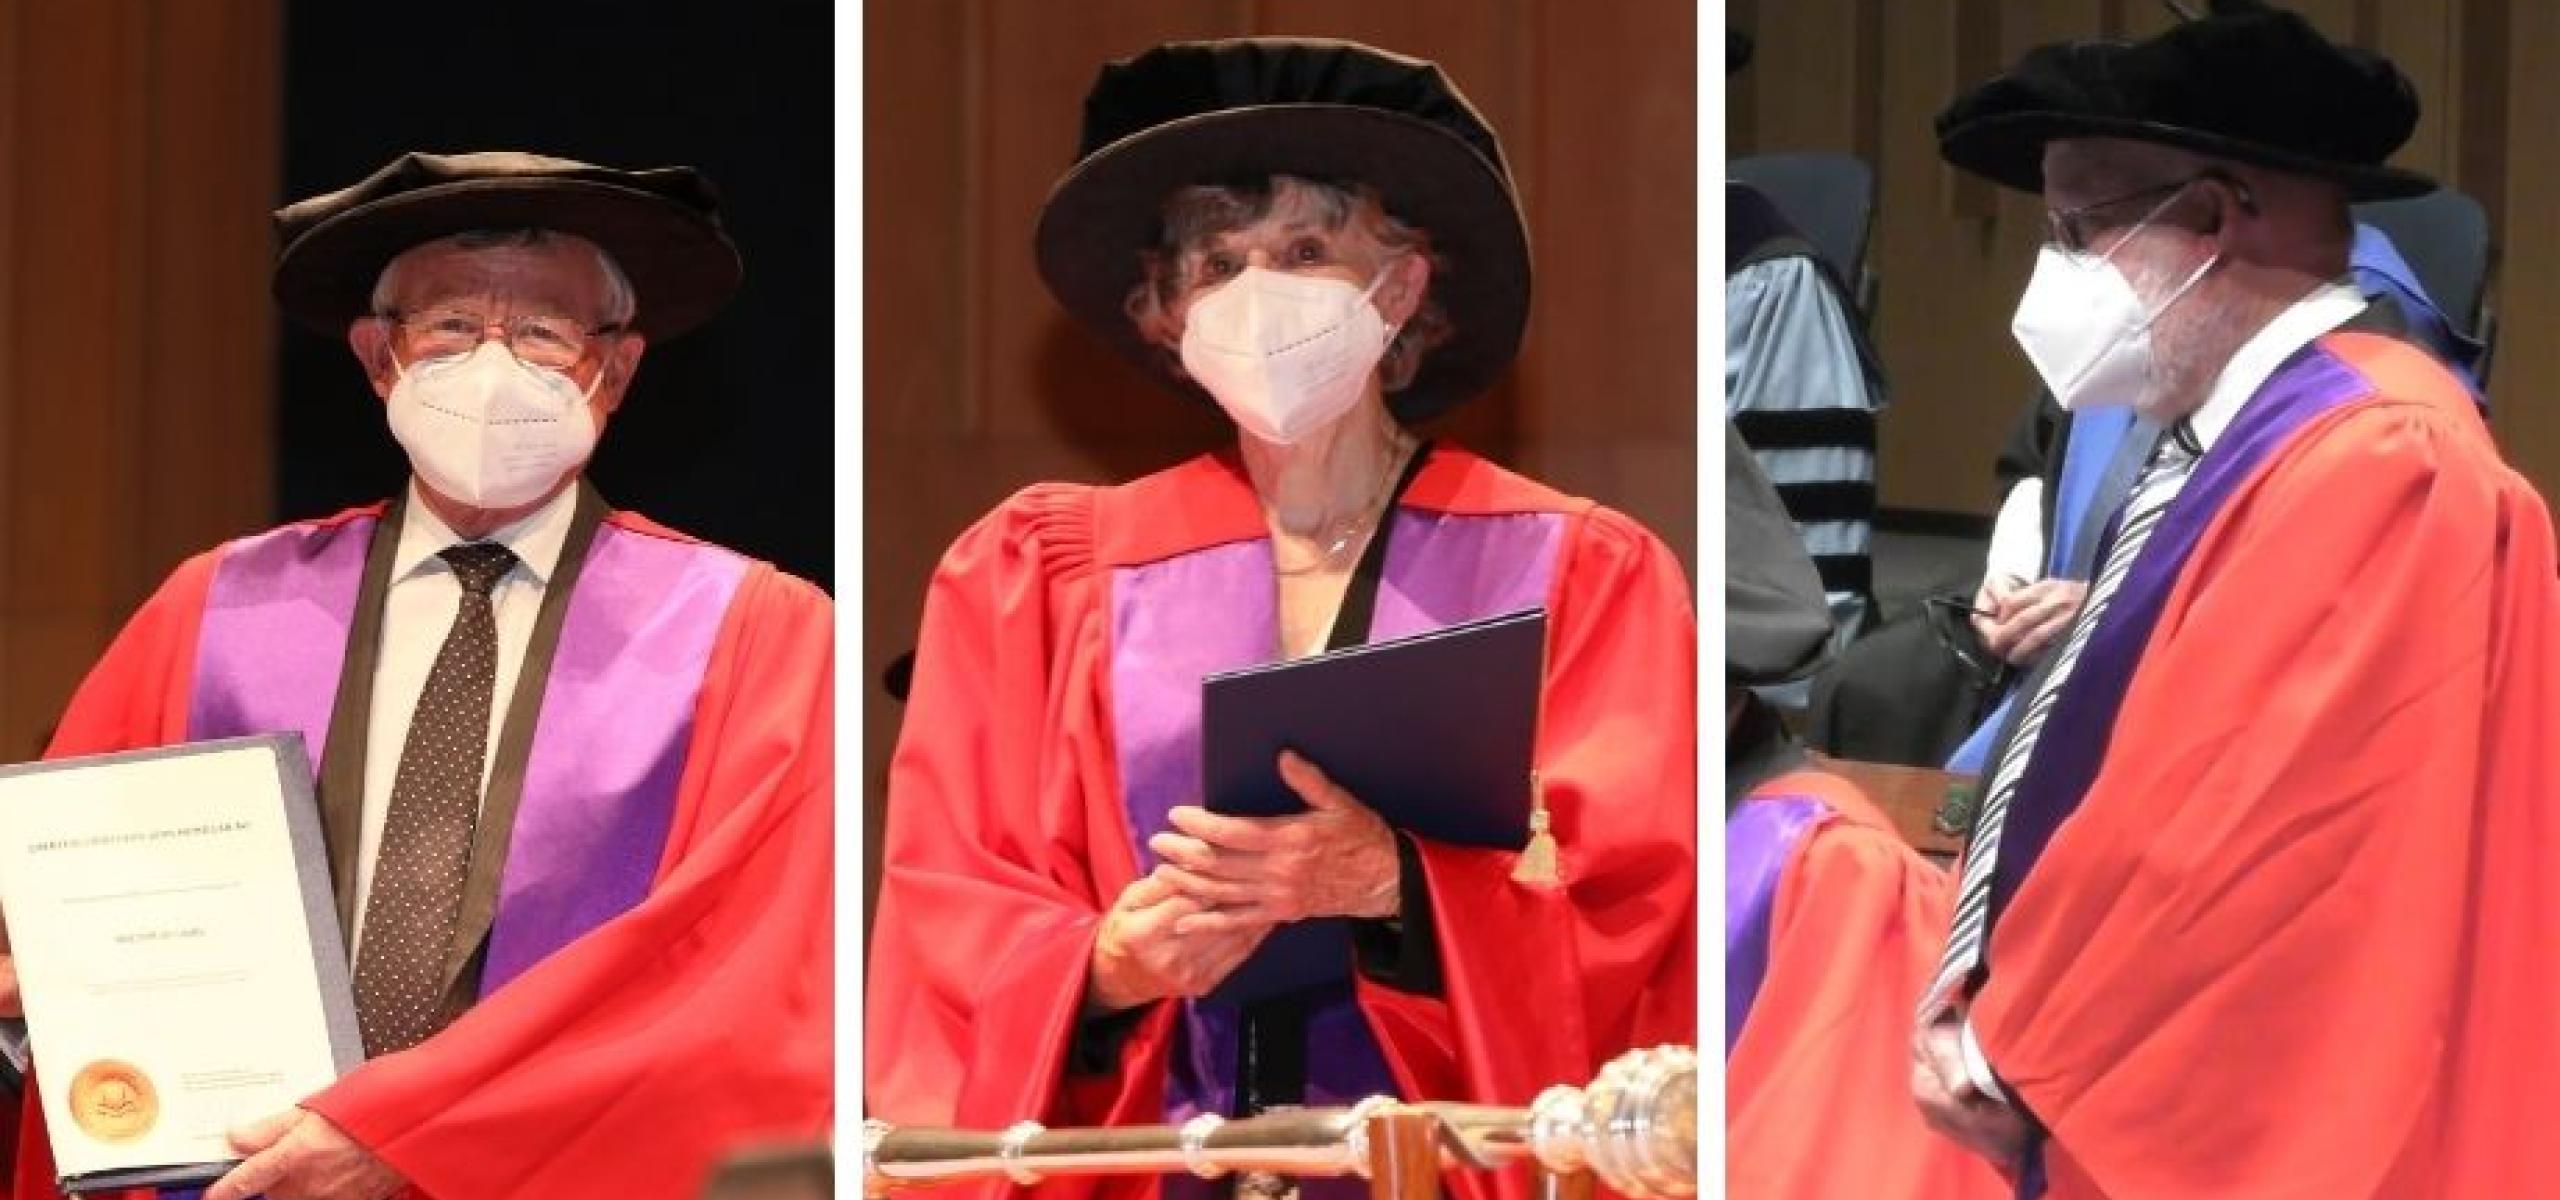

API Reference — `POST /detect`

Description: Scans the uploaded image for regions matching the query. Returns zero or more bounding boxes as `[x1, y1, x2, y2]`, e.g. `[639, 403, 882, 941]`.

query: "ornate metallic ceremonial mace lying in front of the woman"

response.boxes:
[863, 1046, 1697, 1197]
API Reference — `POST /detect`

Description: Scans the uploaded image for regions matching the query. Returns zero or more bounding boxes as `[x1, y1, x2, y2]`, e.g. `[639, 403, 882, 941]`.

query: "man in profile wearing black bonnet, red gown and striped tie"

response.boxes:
[1912, 0, 2560, 1197]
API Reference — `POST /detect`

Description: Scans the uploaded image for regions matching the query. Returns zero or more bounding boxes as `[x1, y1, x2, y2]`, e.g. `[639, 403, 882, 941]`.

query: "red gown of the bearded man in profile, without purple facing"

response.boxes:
[1971, 335, 2560, 1200]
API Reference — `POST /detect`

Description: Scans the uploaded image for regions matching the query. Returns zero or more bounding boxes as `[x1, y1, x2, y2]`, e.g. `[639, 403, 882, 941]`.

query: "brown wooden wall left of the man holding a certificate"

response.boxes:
[0, 0, 276, 760]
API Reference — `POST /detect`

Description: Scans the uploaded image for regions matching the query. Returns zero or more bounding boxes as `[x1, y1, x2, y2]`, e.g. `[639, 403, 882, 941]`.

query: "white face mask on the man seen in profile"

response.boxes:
[2010, 246, 2222, 412]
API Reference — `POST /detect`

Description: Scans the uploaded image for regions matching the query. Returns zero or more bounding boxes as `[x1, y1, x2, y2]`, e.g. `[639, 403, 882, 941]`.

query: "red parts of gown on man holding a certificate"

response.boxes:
[10, 504, 835, 1200]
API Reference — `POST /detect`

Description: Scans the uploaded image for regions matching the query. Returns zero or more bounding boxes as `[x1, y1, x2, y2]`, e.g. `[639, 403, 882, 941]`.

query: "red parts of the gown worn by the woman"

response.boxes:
[863, 450, 1697, 1197]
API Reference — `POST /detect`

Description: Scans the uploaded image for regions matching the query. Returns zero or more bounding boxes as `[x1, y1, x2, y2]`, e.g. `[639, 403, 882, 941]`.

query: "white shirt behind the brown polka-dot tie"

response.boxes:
[351, 481, 579, 944]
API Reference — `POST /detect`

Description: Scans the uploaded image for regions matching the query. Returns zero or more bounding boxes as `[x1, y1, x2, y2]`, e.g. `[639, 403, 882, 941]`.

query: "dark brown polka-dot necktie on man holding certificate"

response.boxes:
[356, 542, 515, 1054]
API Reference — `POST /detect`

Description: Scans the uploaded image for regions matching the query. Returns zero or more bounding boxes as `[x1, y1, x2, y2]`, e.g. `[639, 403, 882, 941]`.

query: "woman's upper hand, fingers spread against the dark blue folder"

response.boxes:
[1147, 752, 1398, 934]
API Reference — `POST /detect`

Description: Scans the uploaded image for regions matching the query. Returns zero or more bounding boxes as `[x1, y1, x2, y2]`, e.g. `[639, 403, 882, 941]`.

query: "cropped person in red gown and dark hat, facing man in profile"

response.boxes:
[1725, 425, 2010, 1200]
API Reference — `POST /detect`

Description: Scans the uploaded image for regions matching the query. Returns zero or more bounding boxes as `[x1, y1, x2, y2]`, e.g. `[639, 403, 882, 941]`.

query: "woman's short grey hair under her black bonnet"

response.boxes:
[1121, 174, 1457, 391]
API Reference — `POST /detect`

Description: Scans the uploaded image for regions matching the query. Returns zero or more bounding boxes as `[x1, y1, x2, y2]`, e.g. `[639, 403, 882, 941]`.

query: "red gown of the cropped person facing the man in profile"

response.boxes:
[1725, 770, 2010, 1200]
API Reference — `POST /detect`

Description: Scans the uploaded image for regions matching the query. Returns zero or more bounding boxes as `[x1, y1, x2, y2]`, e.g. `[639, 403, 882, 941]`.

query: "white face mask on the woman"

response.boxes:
[1183, 266, 1395, 445]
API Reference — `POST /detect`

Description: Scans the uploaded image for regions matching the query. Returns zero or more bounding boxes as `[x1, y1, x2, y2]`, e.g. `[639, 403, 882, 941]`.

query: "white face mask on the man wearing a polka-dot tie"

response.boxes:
[384, 338, 604, 509]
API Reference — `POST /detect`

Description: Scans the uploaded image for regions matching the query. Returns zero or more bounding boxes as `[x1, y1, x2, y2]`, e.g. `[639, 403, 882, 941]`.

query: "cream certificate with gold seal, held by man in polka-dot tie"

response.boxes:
[0, 734, 364, 1192]
